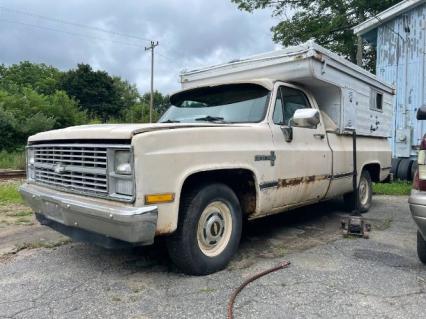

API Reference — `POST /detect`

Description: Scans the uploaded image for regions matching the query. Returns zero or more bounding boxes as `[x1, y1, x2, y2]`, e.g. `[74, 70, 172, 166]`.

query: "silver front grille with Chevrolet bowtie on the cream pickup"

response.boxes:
[31, 144, 108, 196]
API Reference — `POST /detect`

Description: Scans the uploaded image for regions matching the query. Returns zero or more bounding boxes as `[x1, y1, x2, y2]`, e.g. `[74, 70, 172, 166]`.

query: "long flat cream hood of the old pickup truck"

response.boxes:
[28, 123, 240, 142]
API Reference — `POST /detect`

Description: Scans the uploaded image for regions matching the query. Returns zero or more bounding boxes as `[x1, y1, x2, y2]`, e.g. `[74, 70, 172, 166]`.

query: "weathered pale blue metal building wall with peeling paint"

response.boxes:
[376, 4, 426, 157]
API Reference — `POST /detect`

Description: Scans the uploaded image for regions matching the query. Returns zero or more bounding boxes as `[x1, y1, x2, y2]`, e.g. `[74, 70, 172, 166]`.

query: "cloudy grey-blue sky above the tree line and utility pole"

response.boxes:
[0, 0, 278, 93]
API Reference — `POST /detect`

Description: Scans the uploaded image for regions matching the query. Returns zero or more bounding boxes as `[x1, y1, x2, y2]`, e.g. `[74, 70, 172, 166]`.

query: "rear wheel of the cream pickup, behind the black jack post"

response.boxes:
[343, 170, 373, 213]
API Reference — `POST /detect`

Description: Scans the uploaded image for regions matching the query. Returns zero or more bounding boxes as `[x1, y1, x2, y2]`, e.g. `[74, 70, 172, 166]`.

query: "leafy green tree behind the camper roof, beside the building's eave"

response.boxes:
[231, 0, 400, 68]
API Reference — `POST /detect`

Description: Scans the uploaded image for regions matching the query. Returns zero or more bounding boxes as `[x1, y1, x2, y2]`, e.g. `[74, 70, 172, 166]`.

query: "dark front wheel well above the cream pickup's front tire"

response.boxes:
[181, 169, 256, 215]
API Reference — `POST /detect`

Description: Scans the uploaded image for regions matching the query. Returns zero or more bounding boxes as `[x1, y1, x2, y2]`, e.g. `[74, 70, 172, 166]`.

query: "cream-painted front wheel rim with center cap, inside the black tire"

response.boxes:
[197, 201, 232, 257]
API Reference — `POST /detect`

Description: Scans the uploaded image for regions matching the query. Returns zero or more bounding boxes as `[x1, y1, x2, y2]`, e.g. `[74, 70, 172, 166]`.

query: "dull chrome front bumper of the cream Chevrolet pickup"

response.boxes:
[20, 183, 158, 245]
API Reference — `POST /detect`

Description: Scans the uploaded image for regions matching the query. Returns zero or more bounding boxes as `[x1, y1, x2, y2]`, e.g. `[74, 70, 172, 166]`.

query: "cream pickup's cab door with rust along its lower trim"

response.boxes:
[269, 83, 332, 208]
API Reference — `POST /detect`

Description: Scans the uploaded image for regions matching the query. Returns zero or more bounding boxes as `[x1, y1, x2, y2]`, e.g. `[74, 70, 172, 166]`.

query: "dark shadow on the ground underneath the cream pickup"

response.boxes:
[68, 200, 344, 273]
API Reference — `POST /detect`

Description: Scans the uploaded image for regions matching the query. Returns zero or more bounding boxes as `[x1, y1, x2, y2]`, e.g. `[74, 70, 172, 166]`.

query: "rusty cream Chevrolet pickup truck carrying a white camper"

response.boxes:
[21, 43, 393, 275]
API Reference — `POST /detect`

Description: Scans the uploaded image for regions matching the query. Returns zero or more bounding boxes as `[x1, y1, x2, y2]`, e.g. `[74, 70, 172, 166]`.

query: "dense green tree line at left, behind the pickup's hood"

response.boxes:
[0, 61, 169, 151]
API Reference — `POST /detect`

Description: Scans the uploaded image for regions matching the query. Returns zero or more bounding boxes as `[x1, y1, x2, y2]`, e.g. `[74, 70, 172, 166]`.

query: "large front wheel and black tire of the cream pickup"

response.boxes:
[167, 183, 242, 275]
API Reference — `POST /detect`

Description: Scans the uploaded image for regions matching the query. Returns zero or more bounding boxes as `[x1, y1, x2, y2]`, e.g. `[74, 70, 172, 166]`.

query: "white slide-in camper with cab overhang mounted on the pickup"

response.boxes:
[180, 41, 395, 137]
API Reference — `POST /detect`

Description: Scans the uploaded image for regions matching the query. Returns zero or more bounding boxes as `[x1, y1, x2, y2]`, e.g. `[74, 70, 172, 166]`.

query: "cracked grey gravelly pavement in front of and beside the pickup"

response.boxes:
[0, 196, 426, 318]
